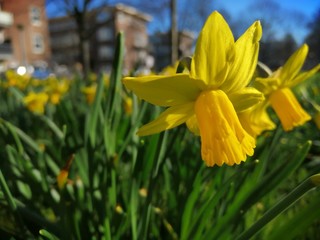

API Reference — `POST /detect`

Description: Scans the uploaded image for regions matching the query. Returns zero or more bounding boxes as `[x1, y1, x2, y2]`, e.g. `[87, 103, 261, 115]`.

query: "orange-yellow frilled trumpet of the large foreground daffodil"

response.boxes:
[195, 90, 255, 166]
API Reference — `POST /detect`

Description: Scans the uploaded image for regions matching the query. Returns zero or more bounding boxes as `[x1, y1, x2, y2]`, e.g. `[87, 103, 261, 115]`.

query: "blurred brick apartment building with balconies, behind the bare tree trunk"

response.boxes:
[49, 4, 151, 72]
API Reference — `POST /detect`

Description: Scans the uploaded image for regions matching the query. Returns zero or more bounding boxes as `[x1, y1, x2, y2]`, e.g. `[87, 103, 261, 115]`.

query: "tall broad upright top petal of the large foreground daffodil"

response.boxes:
[190, 11, 234, 87]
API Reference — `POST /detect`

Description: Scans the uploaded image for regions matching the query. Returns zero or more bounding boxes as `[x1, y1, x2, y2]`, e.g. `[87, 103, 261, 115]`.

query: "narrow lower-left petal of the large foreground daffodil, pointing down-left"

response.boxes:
[137, 102, 194, 136]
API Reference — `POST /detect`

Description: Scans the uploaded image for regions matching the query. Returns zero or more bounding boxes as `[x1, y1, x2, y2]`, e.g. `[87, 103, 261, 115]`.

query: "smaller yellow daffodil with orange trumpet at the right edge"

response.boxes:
[254, 44, 320, 131]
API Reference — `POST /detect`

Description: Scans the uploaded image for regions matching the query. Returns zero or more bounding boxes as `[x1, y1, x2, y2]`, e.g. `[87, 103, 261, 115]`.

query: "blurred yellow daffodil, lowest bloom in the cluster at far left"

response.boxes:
[23, 92, 49, 114]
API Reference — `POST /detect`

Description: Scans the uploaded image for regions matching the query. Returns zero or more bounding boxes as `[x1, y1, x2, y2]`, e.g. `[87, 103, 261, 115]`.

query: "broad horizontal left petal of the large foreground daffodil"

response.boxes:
[122, 74, 200, 107]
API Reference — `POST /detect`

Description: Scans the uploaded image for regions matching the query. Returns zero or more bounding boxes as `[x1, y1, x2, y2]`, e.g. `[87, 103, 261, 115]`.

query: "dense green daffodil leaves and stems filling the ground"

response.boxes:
[0, 34, 320, 240]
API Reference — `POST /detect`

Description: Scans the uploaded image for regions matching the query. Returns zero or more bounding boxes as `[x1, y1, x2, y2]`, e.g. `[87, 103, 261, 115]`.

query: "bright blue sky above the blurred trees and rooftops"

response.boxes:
[47, 0, 320, 44]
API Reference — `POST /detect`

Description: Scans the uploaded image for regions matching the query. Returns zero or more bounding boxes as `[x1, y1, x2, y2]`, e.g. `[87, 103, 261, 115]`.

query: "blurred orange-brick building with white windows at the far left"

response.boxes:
[0, 0, 51, 69]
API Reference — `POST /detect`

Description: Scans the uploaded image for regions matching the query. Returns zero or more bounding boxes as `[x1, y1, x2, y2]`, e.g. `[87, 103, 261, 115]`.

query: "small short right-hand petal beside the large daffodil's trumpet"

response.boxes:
[228, 87, 264, 112]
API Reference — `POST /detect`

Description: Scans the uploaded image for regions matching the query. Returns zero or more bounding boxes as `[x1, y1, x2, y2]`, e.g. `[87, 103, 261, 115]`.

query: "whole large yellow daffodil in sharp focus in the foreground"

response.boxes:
[123, 12, 263, 166]
